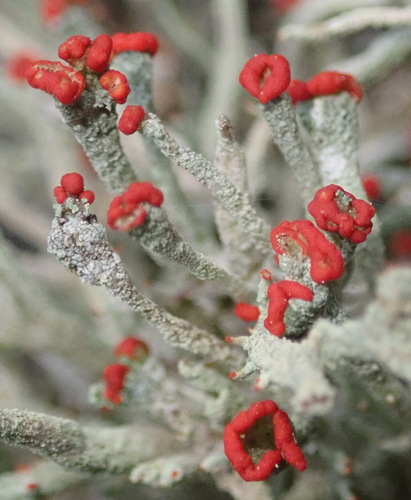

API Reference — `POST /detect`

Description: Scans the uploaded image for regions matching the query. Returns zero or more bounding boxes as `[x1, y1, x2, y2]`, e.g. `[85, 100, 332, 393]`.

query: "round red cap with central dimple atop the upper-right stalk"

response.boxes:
[239, 54, 290, 104]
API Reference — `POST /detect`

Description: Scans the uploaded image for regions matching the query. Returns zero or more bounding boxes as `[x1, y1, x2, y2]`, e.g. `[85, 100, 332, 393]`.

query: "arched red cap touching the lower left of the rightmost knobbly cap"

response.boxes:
[270, 220, 344, 283]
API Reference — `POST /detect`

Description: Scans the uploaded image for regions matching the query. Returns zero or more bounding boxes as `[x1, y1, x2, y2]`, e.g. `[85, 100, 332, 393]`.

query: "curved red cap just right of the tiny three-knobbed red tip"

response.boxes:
[107, 182, 164, 231]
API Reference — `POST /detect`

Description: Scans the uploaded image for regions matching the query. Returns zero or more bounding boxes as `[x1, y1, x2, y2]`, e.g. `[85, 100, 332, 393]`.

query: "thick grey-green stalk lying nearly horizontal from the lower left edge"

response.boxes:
[0, 409, 178, 474]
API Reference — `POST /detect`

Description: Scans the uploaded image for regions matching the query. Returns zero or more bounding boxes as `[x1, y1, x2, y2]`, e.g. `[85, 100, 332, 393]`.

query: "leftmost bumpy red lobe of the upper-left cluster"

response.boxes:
[26, 61, 86, 105]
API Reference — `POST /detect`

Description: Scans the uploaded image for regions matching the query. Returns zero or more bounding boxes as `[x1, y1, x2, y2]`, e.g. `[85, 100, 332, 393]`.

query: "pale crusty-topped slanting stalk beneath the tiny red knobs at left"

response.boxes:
[48, 201, 240, 361]
